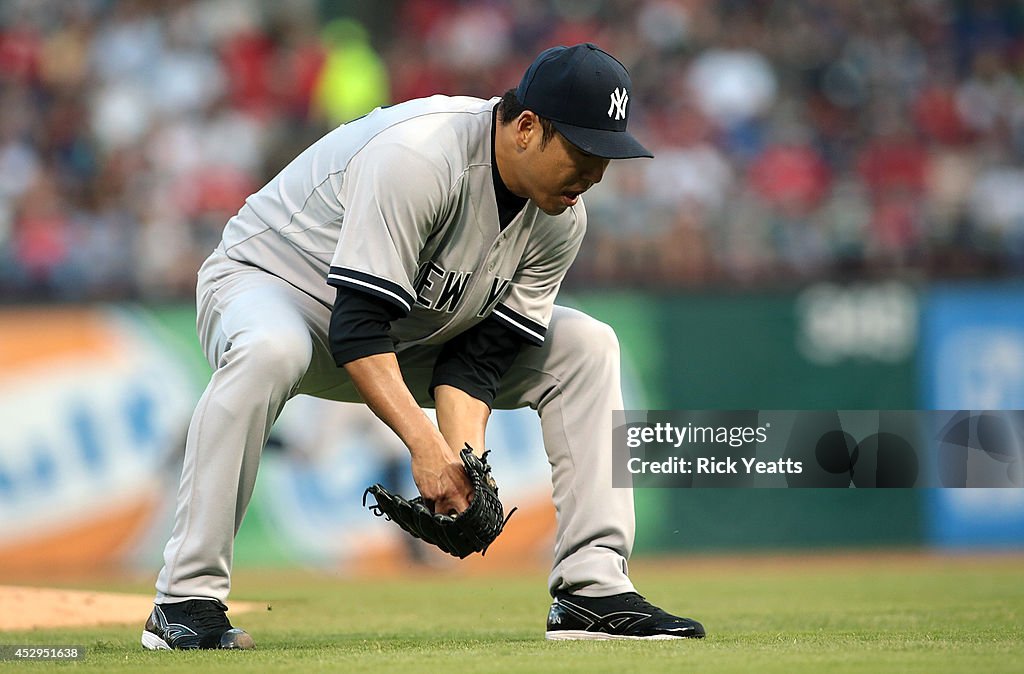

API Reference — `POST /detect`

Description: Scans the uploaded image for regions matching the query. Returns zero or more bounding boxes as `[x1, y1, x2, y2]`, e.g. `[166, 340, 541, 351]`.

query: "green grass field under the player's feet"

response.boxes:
[0, 555, 1024, 674]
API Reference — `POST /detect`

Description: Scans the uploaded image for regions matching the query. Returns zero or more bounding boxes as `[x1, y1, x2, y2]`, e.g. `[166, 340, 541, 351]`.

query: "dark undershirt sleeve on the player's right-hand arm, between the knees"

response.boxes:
[430, 315, 525, 407]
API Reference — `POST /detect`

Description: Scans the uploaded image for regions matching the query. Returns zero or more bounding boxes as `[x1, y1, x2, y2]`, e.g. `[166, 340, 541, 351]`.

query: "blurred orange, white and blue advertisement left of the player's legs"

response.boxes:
[0, 307, 196, 573]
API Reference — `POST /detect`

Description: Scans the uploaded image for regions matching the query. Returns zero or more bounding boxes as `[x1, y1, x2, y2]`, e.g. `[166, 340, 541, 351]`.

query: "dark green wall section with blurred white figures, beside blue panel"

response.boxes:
[573, 282, 923, 553]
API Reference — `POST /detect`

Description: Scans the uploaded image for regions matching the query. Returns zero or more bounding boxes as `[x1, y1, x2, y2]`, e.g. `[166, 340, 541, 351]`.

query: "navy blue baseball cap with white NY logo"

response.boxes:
[515, 42, 654, 159]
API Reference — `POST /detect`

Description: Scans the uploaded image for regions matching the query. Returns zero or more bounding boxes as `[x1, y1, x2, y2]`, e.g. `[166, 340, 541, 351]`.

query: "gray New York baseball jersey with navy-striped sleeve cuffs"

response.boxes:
[222, 95, 587, 351]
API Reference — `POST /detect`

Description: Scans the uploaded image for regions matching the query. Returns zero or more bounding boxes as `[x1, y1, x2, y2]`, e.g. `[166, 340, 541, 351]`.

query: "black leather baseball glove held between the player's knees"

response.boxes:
[362, 445, 516, 559]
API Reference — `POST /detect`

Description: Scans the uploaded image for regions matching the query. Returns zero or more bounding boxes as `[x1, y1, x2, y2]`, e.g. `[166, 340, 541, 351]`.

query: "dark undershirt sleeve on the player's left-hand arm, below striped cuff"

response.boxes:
[328, 287, 401, 368]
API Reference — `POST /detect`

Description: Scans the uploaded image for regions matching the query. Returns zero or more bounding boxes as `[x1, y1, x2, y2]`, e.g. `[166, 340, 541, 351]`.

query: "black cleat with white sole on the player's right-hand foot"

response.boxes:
[544, 592, 705, 640]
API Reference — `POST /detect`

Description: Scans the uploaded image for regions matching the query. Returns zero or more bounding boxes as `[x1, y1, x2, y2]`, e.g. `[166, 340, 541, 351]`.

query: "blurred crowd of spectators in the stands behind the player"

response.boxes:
[0, 0, 1024, 301]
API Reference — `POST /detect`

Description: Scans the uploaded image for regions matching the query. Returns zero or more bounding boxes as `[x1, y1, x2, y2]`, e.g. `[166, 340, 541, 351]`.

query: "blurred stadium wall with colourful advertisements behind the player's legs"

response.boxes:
[0, 282, 1024, 574]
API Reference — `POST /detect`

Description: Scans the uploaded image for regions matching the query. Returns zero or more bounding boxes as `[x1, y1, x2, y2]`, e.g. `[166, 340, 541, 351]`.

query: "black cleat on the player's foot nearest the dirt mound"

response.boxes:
[142, 599, 256, 650]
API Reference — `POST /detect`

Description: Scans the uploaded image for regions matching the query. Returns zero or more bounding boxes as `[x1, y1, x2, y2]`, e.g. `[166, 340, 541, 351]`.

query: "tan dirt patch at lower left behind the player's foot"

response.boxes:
[0, 585, 256, 630]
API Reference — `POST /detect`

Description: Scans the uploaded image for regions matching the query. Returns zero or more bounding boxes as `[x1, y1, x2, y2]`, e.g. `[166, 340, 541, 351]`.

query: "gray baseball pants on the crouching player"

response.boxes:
[156, 252, 635, 603]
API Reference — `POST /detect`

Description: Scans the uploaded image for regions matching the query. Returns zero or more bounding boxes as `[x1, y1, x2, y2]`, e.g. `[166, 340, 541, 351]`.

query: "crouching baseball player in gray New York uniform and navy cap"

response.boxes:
[142, 43, 705, 649]
